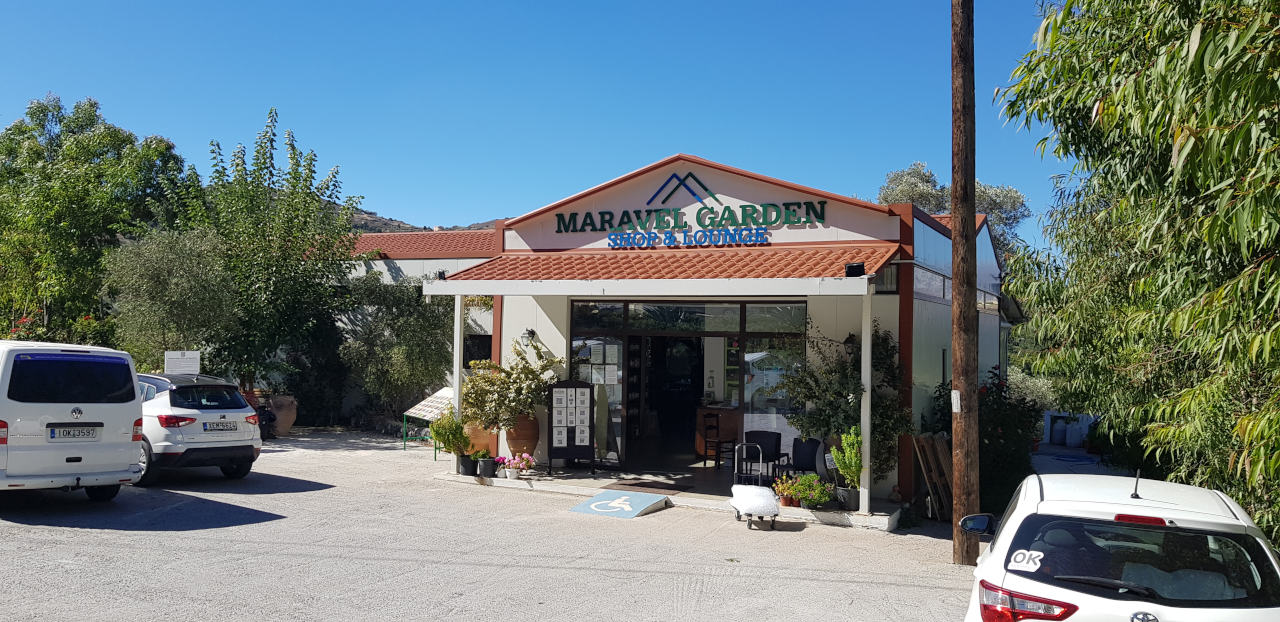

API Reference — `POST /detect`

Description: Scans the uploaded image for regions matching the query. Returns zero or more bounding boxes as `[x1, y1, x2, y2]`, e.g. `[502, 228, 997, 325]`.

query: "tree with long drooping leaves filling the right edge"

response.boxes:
[1002, 0, 1280, 538]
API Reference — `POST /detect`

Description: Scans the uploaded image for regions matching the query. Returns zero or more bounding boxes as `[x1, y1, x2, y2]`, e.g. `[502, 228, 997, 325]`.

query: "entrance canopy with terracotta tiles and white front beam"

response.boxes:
[422, 243, 897, 297]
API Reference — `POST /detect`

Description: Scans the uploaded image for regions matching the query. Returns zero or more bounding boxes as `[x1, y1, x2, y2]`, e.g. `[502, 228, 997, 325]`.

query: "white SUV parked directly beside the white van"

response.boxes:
[138, 374, 262, 486]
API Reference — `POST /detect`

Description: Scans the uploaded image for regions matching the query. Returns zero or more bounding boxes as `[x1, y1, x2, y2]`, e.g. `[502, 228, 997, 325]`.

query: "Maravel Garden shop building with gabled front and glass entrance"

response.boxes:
[424, 155, 1009, 507]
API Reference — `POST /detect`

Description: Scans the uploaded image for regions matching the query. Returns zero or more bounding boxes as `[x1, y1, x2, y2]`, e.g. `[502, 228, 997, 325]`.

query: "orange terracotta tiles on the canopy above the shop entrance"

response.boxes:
[449, 244, 897, 280]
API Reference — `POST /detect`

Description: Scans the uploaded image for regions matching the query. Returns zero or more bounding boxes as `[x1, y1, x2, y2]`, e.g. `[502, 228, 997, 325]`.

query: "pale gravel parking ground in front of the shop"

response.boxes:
[0, 430, 972, 621]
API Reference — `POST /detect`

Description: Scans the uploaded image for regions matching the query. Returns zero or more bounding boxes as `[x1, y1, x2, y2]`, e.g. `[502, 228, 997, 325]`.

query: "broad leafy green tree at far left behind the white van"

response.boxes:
[0, 95, 198, 339]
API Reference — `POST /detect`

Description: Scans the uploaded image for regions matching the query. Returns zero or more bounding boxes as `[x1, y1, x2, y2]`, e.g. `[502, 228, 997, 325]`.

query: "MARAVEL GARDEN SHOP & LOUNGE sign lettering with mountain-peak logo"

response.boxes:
[556, 173, 827, 248]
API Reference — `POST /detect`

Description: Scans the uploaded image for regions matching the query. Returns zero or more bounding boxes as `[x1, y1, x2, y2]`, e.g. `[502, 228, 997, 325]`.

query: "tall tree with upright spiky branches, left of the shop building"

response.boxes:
[199, 109, 361, 387]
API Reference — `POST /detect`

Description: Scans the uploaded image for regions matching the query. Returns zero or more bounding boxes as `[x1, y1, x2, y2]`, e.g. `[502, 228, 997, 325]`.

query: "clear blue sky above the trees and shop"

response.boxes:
[0, 0, 1068, 241]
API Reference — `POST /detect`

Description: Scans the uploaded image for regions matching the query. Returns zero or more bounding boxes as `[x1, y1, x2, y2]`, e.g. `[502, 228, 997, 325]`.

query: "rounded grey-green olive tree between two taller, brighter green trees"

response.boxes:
[105, 228, 237, 369]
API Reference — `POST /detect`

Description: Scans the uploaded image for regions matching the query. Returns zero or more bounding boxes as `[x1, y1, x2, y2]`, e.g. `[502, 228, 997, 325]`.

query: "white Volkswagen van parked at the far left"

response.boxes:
[0, 340, 142, 502]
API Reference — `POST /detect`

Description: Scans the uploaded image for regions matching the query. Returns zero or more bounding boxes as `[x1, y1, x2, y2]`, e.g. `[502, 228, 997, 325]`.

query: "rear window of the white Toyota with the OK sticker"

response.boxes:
[1005, 514, 1280, 607]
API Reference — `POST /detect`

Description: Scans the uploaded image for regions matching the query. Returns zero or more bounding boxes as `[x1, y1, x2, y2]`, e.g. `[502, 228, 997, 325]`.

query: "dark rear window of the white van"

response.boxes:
[8, 352, 138, 404]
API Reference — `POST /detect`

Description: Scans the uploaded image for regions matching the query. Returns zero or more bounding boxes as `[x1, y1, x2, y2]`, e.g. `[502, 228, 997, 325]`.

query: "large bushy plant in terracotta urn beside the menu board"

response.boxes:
[462, 342, 564, 454]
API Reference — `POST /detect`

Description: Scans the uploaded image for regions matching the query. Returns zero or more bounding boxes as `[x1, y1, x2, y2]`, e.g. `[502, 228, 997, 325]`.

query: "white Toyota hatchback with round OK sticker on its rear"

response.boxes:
[960, 475, 1280, 622]
